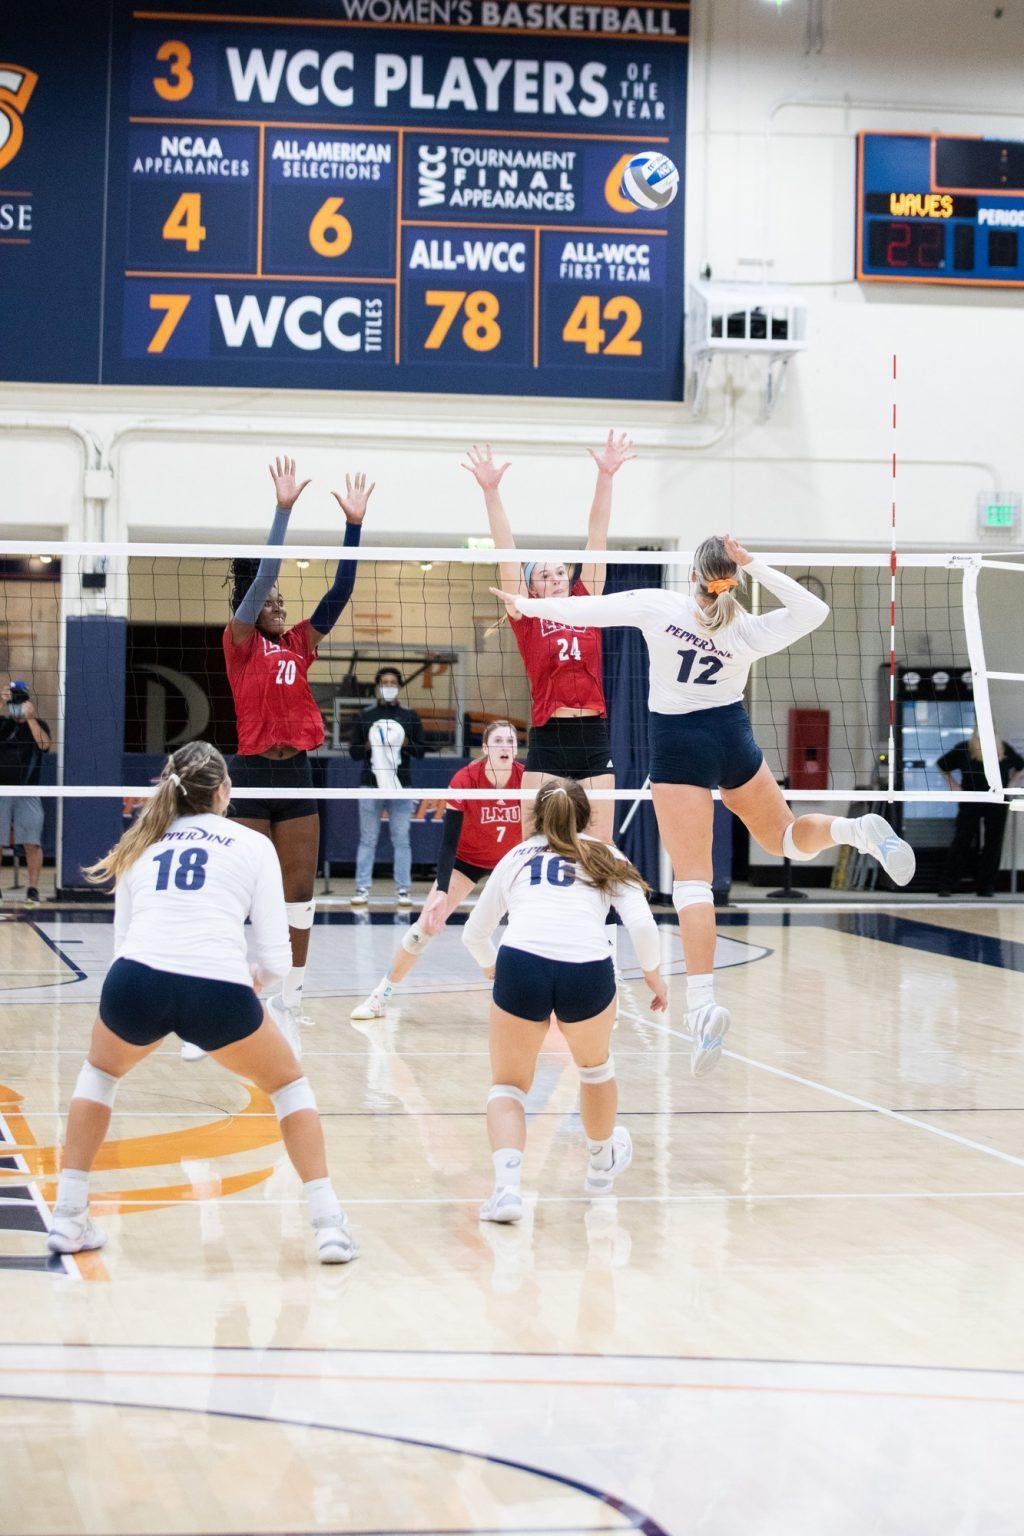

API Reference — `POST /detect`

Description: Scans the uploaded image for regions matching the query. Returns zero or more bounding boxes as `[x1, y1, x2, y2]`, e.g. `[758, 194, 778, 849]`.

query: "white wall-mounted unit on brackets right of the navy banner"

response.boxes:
[688, 281, 808, 421]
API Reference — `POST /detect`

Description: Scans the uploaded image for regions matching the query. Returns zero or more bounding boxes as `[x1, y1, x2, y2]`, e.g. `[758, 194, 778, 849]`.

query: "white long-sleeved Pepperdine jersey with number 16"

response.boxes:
[462, 836, 660, 971]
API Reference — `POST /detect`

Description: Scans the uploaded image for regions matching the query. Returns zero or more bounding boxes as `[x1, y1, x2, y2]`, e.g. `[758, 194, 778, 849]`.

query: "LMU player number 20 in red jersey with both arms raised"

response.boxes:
[224, 458, 373, 1054]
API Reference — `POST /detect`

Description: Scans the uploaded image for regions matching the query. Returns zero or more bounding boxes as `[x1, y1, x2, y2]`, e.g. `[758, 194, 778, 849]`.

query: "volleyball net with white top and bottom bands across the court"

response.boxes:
[0, 541, 1024, 878]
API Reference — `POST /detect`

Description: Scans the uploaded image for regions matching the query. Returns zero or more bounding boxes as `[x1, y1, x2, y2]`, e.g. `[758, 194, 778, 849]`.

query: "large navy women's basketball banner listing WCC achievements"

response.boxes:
[0, 0, 688, 399]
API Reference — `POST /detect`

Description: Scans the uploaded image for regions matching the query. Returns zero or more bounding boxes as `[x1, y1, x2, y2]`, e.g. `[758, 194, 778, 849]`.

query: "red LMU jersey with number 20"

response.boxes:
[223, 619, 324, 756]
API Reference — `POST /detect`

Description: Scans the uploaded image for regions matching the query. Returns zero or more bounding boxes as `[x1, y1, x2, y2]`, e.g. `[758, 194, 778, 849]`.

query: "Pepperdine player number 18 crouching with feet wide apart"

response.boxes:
[48, 742, 356, 1264]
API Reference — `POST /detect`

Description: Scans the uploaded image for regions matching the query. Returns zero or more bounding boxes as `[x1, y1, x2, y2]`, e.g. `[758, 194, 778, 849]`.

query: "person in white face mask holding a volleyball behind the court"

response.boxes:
[348, 667, 427, 906]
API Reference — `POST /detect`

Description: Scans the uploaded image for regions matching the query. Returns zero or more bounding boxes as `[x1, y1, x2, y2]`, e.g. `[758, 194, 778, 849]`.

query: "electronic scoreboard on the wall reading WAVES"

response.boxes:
[857, 134, 1024, 287]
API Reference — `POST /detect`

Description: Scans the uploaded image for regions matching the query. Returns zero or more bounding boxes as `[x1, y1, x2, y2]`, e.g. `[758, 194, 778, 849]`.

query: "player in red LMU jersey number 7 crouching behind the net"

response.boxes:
[352, 720, 524, 1018]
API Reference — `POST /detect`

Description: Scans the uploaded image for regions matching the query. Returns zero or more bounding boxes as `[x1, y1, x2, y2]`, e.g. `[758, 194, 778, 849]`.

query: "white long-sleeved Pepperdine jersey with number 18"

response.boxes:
[114, 813, 292, 986]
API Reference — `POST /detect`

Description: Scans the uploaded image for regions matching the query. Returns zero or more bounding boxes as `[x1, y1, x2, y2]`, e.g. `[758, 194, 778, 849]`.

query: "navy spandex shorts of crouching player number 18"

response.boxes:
[100, 960, 263, 1051]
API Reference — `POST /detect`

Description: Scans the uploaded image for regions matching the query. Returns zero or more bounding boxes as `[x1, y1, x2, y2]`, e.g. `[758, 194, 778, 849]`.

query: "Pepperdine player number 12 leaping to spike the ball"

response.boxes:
[494, 535, 915, 1077]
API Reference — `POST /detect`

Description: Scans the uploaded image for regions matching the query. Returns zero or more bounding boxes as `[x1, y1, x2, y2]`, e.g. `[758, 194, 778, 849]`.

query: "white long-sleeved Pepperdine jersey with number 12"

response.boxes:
[516, 559, 829, 714]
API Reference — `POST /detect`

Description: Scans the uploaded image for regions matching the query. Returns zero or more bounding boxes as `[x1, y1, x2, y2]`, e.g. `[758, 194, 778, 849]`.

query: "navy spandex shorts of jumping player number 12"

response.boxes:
[648, 703, 765, 790]
